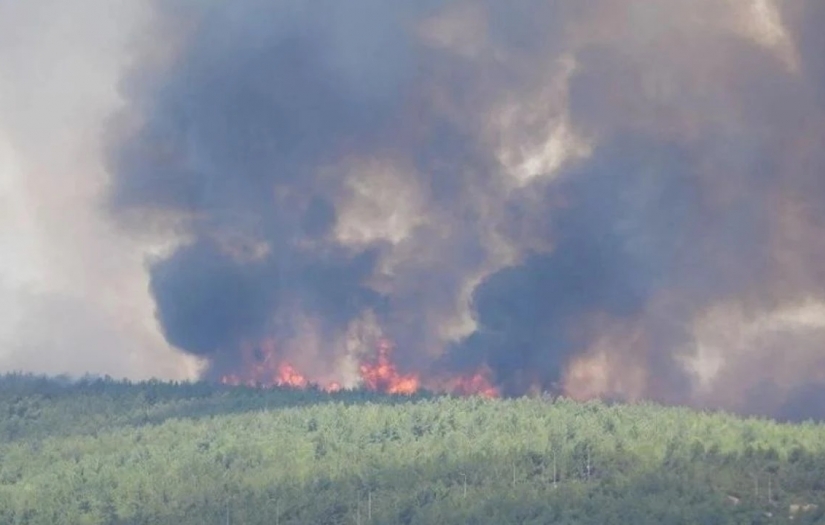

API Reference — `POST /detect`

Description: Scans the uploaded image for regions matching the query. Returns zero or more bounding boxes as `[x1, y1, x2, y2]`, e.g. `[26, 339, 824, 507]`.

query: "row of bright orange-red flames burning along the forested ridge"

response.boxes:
[220, 339, 499, 398]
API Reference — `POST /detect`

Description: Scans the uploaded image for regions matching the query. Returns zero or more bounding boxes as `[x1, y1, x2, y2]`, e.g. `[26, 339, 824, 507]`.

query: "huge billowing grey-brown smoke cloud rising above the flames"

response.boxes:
[108, 0, 825, 413]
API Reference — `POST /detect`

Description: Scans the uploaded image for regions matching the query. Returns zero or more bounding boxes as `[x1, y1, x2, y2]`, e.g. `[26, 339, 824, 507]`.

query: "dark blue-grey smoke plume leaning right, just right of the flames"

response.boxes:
[450, 135, 700, 393]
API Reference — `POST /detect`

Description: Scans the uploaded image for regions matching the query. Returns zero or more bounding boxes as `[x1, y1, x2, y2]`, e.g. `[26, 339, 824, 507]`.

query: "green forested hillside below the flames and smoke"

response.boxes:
[0, 374, 825, 525]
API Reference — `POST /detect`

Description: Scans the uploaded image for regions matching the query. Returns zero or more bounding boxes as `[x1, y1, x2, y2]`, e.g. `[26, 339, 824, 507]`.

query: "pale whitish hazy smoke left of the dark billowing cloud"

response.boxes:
[0, 0, 196, 378]
